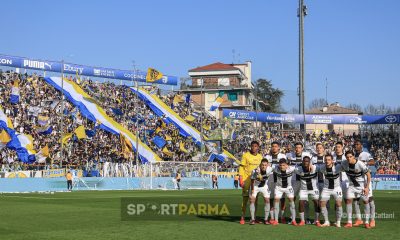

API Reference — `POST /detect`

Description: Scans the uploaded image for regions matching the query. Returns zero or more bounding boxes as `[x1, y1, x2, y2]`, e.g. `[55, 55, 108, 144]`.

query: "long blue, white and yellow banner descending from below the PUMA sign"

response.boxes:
[44, 77, 161, 162]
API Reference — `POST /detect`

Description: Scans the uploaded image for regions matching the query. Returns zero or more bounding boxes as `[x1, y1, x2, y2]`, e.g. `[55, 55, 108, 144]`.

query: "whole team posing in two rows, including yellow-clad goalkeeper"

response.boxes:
[239, 140, 375, 228]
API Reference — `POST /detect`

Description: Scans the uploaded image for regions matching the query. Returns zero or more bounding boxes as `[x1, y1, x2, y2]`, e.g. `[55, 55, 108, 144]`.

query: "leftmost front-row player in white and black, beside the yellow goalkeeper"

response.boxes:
[250, 159, 272, 225]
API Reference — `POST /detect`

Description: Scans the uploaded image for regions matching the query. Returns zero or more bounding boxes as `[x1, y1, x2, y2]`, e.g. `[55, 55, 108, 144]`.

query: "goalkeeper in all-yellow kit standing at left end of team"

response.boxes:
[239, 141, 262, 224]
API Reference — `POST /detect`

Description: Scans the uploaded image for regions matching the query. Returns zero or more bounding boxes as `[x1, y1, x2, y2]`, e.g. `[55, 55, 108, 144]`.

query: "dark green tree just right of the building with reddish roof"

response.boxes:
[253, 78, 284, 112]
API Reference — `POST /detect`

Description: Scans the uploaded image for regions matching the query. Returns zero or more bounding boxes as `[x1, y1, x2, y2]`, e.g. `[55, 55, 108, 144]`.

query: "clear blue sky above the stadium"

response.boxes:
[0, 0, 400, 111]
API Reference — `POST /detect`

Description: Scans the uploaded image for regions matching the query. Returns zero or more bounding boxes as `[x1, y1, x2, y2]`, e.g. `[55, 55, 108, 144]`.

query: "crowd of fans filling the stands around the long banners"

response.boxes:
[0, 69, 399, 174]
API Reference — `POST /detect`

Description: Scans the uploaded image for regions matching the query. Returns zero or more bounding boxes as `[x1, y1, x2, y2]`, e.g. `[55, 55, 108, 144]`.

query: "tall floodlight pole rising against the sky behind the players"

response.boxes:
[297, 0, 307, 142]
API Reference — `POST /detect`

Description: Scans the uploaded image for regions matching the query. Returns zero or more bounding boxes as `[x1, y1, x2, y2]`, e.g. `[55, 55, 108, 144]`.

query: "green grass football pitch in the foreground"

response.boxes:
[0, 190, 400, 240]
